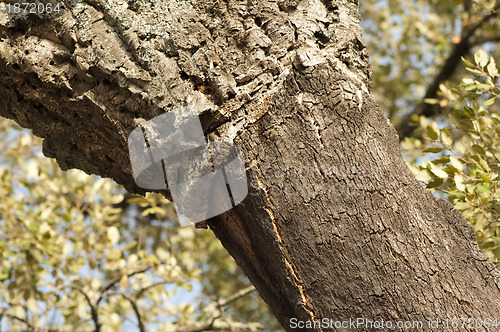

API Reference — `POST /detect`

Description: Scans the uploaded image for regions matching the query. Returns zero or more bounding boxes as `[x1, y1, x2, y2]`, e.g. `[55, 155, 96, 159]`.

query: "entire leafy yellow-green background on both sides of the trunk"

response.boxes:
[0, 0, 500, 332]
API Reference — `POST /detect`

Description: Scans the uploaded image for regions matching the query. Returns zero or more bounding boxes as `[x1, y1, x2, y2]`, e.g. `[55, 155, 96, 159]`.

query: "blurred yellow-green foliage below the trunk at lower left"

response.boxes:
[0, 120, 277, 331]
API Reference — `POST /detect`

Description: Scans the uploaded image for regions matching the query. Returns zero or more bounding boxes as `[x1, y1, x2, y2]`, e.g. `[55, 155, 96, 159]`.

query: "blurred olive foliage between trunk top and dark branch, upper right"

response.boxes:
[360, 0, 500, 125]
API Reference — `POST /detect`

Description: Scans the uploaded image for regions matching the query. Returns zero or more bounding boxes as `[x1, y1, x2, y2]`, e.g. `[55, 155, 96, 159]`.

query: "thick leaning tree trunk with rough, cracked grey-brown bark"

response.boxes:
[0, 0, 500, 331]
